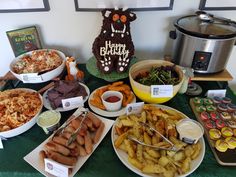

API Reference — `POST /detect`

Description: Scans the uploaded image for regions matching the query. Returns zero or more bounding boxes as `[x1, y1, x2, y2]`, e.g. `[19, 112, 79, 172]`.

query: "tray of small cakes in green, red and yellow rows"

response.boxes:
[190, 97, 236, 166]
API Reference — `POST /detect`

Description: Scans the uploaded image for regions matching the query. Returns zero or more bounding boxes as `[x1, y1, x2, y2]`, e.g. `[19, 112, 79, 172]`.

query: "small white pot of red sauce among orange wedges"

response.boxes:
[101, 91, 123, 111]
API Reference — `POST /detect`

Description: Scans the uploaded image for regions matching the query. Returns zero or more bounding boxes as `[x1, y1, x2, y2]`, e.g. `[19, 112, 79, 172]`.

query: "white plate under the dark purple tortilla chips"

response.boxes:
[43, 82, 90, 112]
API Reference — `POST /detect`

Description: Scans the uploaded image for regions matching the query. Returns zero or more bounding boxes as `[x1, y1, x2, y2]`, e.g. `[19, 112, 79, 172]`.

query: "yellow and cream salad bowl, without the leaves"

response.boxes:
[129, 60, 184, 103]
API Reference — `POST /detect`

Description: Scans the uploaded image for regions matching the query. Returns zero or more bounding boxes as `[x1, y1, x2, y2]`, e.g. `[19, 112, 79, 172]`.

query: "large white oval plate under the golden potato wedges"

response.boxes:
[111, 105, 205, 177]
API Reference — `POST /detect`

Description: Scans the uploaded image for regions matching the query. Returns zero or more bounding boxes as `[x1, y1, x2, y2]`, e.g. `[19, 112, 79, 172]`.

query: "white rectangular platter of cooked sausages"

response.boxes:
[24, 108, 114, 177]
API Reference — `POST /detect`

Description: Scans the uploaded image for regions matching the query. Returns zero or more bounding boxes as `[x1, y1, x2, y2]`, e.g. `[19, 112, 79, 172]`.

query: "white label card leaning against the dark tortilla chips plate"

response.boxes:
[61, 96, 84, 109]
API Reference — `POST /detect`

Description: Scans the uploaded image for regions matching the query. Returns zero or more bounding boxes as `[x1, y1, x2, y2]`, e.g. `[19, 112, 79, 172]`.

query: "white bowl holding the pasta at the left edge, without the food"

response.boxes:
[0, 88, 43, 138]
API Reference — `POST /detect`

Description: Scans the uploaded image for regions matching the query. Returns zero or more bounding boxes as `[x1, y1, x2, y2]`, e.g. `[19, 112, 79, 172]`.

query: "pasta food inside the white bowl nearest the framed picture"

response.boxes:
[12, 50, 63, 74]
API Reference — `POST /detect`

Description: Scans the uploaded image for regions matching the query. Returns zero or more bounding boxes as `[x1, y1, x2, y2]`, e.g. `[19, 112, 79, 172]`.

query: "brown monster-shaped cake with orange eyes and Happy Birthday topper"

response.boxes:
[93, 9, 136, 73]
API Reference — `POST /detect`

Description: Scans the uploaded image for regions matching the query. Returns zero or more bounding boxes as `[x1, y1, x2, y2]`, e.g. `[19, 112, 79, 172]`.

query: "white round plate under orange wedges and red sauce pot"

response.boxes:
[88, 86, 136, 117]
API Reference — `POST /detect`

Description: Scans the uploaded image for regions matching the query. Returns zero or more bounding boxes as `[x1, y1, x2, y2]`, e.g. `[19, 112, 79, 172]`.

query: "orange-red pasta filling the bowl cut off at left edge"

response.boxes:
[0, 89, 42, 132]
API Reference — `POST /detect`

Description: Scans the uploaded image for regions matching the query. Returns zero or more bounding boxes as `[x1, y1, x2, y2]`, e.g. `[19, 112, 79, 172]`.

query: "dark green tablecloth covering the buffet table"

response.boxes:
[0, 65, 236, 177]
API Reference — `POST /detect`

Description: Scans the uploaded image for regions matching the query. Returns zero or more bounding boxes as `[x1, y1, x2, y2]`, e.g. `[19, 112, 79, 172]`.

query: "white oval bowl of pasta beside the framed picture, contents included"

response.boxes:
[10, 49, 66, 83]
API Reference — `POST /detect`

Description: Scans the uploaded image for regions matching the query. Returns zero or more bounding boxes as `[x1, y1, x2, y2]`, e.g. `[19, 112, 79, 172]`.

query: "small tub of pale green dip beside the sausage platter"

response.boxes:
[37, 110, 61, 134]
